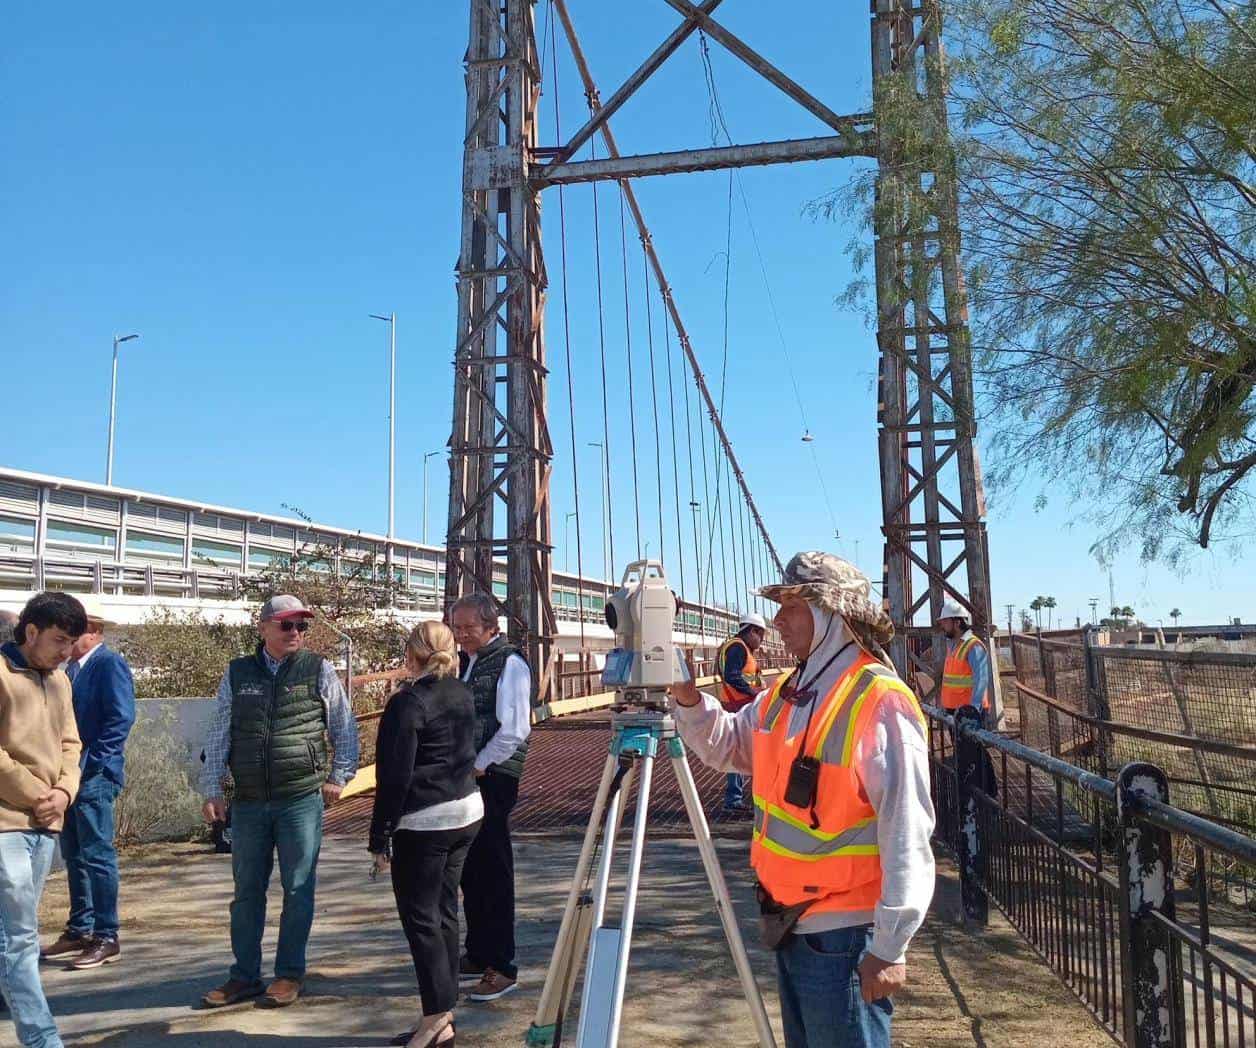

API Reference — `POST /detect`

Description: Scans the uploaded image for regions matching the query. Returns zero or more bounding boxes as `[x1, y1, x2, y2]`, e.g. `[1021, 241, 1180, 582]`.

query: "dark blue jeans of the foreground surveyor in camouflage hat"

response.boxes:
[776, 925, 894, 1048]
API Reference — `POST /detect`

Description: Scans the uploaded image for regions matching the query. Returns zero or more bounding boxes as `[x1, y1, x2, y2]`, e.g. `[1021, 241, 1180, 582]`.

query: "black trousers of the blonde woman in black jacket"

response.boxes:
[392, 823, 480, 1015]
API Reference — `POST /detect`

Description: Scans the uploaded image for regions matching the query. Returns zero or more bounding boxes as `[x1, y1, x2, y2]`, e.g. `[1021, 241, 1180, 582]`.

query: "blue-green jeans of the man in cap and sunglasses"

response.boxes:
[231, 790, 323, 983]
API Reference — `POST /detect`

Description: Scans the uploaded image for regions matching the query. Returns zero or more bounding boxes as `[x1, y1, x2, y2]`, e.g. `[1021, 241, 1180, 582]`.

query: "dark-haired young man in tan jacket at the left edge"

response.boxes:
[0, 593, 87, 1048]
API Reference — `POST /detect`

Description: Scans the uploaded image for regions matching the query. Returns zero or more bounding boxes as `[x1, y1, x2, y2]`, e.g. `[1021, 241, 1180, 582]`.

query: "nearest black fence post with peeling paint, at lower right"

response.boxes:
[1117, 761, 1186, 1048]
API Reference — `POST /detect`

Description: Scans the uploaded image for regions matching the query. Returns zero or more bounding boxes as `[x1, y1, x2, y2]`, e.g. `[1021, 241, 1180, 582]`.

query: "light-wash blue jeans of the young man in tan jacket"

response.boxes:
[0, 829, 63, 1048]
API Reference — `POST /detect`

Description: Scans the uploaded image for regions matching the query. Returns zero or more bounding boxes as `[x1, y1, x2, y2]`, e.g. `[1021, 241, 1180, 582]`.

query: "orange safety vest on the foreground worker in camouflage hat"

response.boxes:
[750, 653, 924, 914]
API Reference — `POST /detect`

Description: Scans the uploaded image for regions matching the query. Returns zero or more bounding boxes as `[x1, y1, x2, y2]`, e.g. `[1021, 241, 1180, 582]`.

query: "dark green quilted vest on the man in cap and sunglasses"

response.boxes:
[227, 645, 328, 800]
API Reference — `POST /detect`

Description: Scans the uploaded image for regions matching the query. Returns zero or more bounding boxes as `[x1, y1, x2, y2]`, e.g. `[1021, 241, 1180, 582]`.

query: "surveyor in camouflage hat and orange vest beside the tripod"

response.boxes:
[672, 553, 933, 1048]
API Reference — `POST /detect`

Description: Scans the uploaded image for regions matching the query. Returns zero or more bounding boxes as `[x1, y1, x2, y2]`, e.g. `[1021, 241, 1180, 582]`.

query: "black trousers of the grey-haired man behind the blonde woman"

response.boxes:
[462, 772, 519, 979]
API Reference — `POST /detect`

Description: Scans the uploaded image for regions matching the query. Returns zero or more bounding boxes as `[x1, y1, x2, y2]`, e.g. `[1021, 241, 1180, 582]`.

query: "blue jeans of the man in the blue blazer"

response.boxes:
[62, 774, 118, 940]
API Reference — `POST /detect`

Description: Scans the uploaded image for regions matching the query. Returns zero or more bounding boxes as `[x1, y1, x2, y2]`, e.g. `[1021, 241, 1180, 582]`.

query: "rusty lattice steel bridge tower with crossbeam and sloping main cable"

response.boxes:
[446, 0, 990, 696]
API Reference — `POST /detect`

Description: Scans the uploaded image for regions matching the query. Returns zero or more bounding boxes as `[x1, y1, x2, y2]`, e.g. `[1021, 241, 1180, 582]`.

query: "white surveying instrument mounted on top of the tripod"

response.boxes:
[602, 560, 690, 710]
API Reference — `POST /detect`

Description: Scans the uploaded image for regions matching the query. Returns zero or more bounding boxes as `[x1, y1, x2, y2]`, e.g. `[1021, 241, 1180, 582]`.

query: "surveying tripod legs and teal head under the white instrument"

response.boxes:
[528, 701, 776, 1048]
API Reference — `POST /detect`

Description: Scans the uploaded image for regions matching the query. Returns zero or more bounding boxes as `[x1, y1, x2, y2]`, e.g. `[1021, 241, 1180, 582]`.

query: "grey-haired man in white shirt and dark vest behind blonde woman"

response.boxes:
[450, 593, 533, 1002]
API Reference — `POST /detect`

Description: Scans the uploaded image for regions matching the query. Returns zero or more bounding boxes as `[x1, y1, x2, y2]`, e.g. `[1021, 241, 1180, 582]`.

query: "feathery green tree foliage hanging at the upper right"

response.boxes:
[815, 0, 1256, 562]
